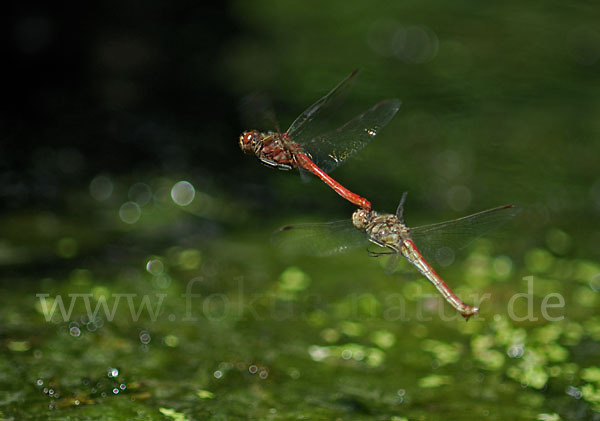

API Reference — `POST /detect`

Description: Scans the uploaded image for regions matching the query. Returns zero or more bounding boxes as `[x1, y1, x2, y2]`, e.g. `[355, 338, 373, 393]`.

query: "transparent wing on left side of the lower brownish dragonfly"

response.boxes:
[271, 219, 368, 257]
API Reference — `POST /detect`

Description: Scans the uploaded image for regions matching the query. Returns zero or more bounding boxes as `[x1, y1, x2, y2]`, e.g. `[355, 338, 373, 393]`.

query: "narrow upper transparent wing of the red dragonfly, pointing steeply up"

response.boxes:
[287, 70, 359, 141]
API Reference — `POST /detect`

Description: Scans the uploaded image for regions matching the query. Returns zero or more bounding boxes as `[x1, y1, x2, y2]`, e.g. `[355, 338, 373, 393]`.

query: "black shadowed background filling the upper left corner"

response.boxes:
[0, 2, 242, 208]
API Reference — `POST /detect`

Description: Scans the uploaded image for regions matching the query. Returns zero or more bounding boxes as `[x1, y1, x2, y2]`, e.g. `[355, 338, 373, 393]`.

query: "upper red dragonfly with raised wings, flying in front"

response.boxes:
[239, 70, 401, 209]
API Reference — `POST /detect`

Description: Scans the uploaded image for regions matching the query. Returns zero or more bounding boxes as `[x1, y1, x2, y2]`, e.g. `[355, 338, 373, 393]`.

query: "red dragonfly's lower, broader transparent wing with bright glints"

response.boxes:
[300, 99, 402, 172]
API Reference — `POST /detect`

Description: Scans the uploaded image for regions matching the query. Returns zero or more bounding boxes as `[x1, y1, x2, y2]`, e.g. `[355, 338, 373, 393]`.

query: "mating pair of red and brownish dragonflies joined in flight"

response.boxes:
[239, 71, 520, 320]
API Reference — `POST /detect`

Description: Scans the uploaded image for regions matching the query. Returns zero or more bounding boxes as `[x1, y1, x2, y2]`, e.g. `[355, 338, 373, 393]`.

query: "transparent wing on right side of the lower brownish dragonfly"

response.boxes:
[410, 205, 521, 266]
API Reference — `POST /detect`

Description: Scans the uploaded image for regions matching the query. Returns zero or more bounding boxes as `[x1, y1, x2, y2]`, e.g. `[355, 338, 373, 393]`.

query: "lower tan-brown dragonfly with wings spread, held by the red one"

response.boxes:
[272, 193, 521, 320]
